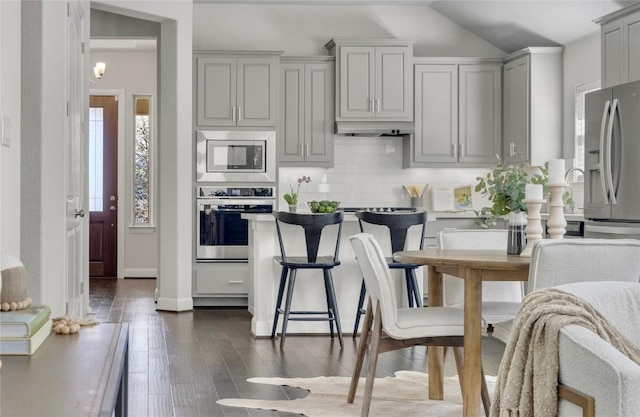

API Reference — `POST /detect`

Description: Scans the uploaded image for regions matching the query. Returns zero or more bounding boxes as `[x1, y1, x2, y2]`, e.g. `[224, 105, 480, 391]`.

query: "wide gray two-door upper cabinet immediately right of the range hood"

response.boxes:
[403, 58, 502, 168]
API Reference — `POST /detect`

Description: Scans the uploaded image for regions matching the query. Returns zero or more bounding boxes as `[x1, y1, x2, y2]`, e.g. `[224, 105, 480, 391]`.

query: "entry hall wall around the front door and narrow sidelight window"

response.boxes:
[90, 51, 158, 277]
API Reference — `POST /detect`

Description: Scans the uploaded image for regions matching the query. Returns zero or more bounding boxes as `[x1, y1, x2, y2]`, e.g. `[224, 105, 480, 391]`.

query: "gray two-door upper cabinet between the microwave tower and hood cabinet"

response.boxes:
[278, 57, 335, 167]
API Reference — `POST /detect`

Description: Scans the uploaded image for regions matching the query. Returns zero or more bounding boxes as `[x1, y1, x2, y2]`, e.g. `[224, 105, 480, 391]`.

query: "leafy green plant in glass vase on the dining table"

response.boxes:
[475, 158, 547, 254]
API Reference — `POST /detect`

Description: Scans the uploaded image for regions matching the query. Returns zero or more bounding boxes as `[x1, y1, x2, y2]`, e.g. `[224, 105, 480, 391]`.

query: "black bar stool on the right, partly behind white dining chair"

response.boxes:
[353, 211, 427, 339]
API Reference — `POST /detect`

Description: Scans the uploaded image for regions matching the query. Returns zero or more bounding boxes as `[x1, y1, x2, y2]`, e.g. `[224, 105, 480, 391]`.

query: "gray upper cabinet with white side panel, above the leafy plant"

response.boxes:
[502, 47, 563, 165]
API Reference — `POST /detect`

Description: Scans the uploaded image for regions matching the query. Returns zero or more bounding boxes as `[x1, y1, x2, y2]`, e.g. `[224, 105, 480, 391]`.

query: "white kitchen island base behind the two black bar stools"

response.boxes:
[242, 213, 423, 337]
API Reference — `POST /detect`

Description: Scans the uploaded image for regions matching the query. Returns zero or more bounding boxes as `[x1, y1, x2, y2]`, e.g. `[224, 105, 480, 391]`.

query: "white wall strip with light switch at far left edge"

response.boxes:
[0, 1, 22, 257]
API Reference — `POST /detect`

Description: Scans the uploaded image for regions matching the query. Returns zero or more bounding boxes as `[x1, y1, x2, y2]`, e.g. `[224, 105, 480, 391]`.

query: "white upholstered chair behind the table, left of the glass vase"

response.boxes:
[436, 229, 524, 333]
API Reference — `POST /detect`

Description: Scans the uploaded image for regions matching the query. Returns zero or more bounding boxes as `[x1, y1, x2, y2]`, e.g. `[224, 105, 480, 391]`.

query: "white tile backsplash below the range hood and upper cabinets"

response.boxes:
[278, 136, 488, 210]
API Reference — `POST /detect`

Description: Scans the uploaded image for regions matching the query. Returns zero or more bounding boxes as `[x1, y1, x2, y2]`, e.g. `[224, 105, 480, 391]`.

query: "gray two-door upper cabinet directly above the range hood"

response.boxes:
[326, 39, 413, 121]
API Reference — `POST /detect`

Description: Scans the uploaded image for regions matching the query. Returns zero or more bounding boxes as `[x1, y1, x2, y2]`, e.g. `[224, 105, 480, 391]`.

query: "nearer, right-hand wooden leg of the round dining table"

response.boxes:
[462, 269, 482, 417]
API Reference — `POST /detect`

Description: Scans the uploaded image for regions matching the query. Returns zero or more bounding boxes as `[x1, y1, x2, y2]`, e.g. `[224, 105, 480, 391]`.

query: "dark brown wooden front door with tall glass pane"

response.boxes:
[88, 95, 118, 277]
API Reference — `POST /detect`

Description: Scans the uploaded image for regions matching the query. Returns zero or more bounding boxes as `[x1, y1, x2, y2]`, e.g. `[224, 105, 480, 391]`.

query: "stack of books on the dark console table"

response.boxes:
[0, 305, 53, 355]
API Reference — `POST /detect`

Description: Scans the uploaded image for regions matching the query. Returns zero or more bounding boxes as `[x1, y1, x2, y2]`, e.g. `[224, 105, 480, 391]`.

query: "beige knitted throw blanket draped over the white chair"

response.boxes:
[490, 288, 640, 417]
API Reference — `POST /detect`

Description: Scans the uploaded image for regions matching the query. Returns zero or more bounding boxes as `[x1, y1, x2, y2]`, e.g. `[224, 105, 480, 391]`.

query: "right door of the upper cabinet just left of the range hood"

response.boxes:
[304, 63, 335, 162]
